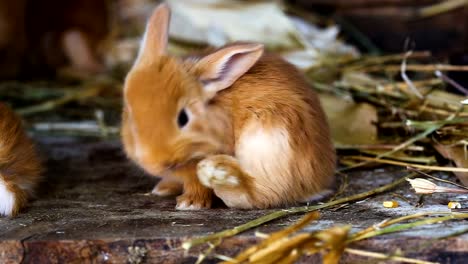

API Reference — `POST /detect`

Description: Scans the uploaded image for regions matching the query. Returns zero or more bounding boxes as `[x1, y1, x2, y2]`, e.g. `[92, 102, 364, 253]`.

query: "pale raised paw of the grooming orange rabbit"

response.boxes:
[197, 159, 239, 188]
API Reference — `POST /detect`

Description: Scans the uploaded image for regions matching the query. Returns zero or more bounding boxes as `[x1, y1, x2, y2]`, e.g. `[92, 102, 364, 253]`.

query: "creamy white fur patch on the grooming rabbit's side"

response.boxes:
[236, 122, 292, 195]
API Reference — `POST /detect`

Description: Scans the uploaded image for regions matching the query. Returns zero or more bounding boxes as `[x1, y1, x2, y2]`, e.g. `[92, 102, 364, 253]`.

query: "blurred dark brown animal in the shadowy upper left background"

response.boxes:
[0, 0, 110, 78]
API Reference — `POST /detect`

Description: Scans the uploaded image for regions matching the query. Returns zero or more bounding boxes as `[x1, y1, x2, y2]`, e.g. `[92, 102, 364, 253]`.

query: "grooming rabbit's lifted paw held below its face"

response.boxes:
[197, 155, 240, 188]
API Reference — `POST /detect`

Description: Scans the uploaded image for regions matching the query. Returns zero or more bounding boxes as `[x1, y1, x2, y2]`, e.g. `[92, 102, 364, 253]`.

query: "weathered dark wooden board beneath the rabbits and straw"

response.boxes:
[0, 137, 468, 263]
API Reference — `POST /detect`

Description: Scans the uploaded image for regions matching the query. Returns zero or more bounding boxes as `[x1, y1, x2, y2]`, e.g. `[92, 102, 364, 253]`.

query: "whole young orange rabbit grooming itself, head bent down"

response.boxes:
[122, 4, 335, 210]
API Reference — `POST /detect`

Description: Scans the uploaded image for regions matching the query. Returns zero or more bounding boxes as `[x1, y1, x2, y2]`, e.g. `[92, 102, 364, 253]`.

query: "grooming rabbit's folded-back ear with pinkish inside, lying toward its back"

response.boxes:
[197, 43, 263, 96]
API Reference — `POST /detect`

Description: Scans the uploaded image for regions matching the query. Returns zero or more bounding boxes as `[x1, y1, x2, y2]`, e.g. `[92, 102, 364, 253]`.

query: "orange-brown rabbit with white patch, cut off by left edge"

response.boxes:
[0, 103, 42, 216]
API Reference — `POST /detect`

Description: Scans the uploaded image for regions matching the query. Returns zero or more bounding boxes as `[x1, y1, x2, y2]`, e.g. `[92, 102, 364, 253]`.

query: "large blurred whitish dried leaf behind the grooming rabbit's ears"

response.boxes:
[168, 0, 359, 70]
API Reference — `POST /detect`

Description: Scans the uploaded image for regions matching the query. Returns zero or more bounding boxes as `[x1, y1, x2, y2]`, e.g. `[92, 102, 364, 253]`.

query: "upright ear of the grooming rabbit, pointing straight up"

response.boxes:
[135, 3, 171, 65]
